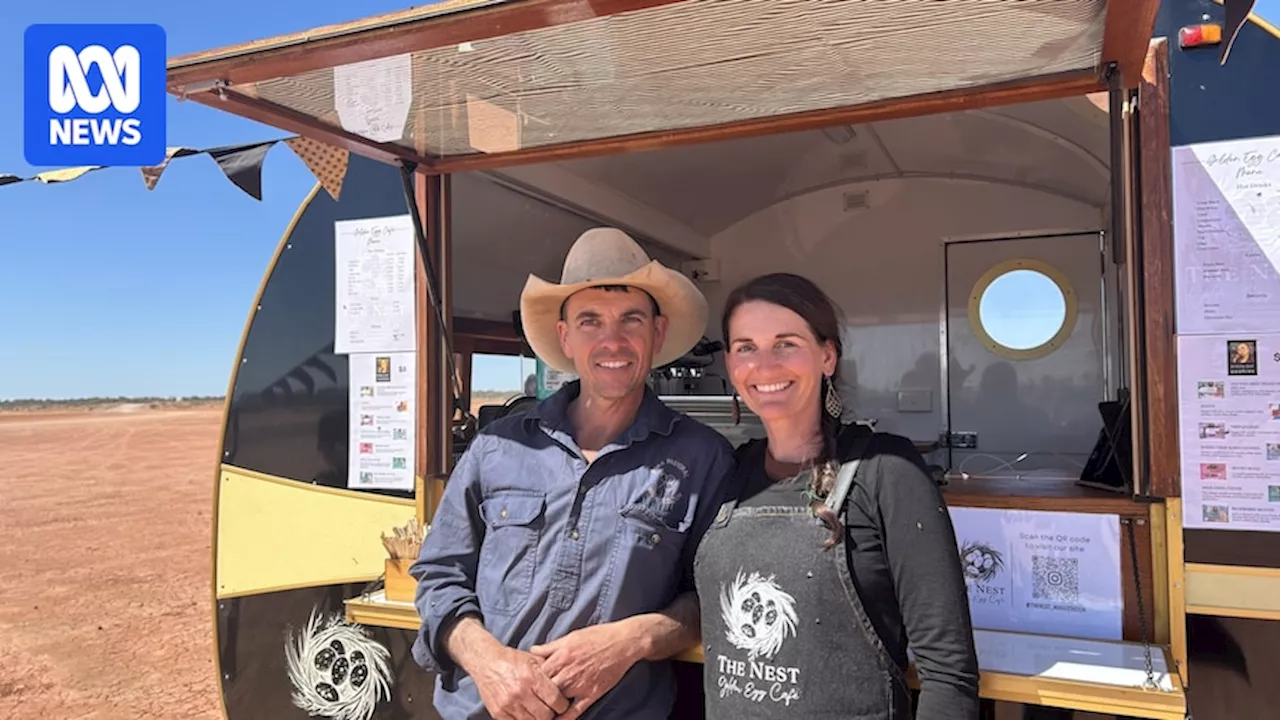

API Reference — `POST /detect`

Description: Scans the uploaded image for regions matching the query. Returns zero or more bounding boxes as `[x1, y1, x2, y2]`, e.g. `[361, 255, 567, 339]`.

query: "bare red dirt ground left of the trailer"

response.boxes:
[0, 405, 221, 720]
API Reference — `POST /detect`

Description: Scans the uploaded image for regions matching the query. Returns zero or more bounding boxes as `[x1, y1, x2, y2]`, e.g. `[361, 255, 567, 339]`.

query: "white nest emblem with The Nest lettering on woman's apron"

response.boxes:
[716, 570, 800, 706]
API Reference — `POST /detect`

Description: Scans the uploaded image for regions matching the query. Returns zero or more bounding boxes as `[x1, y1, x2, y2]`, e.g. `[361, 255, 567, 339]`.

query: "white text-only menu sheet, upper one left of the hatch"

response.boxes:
[334, 215, 416, 355]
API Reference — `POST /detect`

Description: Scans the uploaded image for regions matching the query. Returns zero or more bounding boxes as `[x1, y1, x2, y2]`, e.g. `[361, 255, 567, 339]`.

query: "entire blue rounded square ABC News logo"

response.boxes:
[23, 24, 168, 167]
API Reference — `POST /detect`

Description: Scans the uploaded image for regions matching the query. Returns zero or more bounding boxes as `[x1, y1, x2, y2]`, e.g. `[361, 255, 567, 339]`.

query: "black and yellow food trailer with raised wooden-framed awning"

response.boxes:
[168, 0, 1280, 720]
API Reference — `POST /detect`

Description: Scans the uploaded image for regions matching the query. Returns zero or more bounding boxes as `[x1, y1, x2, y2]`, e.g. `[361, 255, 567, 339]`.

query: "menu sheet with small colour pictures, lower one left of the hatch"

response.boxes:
[347, 352, 417, 492]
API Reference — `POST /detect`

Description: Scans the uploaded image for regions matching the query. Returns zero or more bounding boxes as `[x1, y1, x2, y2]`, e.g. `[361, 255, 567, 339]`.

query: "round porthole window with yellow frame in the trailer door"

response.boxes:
[969, 259, 1076, 360]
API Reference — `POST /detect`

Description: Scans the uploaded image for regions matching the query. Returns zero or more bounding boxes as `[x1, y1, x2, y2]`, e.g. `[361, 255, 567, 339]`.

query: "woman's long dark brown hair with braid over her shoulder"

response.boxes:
[721, 273, 845, 548]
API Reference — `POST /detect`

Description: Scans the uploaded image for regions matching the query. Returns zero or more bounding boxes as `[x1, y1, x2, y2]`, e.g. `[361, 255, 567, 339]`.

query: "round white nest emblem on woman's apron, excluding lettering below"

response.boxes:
[721, 570, 796, 660]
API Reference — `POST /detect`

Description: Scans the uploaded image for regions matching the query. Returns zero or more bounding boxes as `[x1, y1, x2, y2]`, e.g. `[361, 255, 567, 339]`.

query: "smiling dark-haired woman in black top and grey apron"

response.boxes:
[695, 274, 978, 720]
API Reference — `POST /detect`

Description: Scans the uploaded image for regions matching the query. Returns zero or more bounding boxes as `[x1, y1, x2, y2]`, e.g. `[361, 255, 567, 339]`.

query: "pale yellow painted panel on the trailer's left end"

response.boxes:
[214, 465, 415, 598]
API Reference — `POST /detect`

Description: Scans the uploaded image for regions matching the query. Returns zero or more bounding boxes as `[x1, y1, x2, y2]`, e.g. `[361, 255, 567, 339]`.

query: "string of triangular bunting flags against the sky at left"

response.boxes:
[0, 137, 351, 200]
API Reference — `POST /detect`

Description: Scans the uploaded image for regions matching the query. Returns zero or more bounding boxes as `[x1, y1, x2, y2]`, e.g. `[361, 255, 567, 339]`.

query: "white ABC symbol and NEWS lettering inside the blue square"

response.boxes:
[49, 45, 142, 145]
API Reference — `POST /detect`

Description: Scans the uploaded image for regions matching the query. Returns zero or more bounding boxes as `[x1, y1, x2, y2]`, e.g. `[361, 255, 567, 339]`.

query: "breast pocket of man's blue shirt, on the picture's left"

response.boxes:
[476, 491, 547, 614]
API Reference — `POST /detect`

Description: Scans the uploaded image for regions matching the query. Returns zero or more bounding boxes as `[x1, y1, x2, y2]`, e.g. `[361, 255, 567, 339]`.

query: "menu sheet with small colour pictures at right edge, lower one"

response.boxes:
[1178, 333, 1280, 530]
